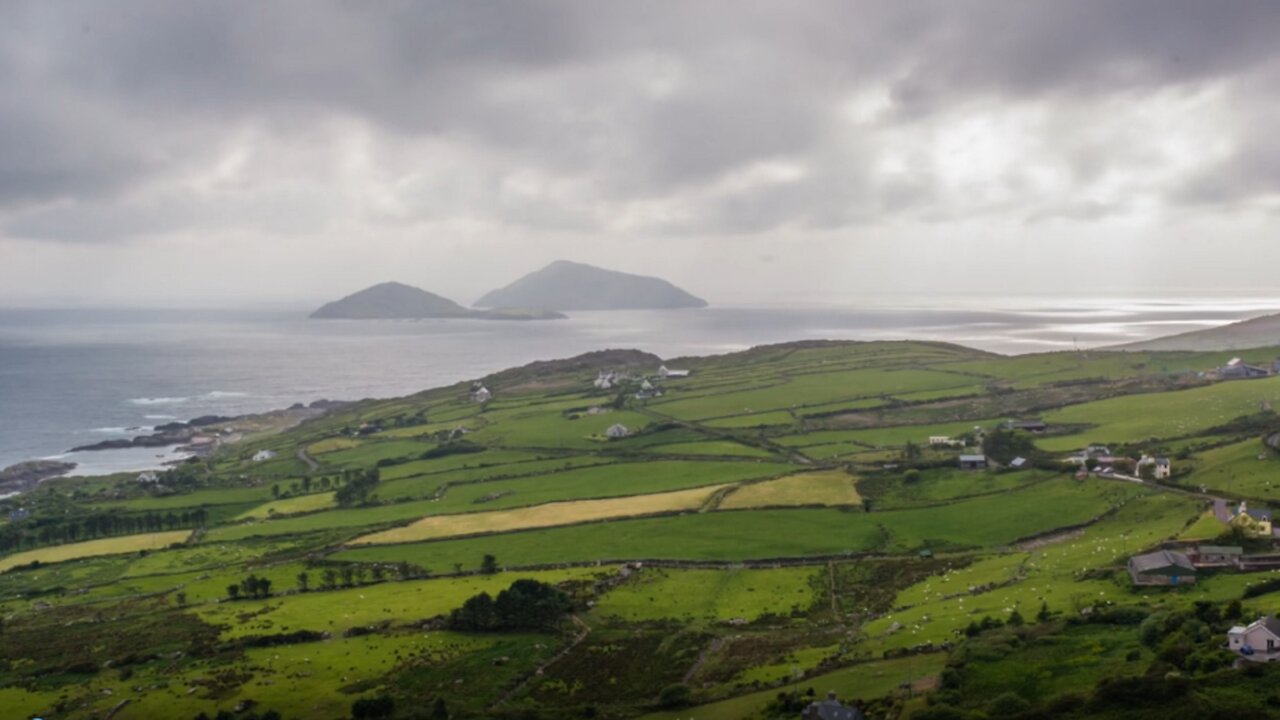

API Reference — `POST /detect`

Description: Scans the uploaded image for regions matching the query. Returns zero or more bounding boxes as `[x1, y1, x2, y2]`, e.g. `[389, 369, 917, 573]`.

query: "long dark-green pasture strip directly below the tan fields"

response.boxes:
[335, 479, 1144, 568]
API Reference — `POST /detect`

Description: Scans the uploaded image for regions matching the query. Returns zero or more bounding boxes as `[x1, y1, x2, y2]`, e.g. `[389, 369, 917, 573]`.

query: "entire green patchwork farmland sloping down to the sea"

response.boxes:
[0, 342, 1280, 720]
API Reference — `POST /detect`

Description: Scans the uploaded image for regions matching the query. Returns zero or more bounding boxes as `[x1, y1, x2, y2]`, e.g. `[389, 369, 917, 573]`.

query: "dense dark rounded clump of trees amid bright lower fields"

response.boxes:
[448, 579, 573, 632]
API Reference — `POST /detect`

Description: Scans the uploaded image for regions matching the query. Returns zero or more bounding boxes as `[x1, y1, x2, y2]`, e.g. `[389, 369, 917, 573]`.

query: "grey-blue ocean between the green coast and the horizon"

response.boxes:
[0, 299, 1280, 474]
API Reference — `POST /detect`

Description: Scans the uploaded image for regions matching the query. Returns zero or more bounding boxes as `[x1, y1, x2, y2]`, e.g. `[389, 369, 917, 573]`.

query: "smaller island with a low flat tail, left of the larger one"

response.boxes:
[311, 282, 564, 320]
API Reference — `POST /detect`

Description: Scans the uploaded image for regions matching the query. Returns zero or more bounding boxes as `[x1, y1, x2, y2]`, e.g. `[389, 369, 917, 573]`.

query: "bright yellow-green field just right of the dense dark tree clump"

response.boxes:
[593, 566, 826, 623]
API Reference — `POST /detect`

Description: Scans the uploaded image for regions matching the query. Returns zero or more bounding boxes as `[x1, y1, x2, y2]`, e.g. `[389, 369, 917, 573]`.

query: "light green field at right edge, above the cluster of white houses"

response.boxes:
[1038, 378, 1280, 451]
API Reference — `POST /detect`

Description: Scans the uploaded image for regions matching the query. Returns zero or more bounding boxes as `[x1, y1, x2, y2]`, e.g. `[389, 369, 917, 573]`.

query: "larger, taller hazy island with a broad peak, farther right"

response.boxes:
[475, 260, 707, 310]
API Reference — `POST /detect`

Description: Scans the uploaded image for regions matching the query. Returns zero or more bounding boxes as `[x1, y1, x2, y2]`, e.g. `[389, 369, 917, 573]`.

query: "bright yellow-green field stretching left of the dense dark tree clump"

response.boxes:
[191, 566, 600, 638]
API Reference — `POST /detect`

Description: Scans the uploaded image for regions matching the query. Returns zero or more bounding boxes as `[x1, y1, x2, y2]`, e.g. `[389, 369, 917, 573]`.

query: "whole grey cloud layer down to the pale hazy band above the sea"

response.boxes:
[0, 0, 1280, 302]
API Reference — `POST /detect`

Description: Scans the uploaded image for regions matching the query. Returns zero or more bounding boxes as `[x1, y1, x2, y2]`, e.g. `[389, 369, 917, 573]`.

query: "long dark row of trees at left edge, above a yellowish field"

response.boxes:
[0, 509, 209, 552]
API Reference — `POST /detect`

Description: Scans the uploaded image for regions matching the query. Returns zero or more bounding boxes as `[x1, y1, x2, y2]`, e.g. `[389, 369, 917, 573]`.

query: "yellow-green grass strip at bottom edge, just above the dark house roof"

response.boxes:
[640, 652, 947, 720]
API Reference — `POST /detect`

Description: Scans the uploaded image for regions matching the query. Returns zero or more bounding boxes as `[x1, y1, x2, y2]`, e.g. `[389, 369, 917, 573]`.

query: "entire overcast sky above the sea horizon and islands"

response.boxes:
[0, 0, 1280, 307]
